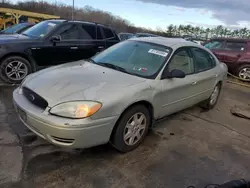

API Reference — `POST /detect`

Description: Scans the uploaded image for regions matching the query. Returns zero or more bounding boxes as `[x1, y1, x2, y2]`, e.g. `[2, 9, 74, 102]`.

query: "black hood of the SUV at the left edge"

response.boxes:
[0, 34, 33, 44]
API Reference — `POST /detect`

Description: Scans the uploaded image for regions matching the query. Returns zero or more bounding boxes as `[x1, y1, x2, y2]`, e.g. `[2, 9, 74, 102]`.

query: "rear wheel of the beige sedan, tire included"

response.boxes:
[201, 83, 221, 110]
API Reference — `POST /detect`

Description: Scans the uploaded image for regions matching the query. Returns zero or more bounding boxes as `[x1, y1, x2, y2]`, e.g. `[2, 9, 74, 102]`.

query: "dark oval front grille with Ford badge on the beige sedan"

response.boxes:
[23, 87, 48, 109]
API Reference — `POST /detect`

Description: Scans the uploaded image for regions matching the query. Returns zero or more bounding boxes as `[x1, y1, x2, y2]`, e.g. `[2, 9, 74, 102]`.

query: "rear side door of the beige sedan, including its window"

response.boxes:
[191, 47, 219, 101]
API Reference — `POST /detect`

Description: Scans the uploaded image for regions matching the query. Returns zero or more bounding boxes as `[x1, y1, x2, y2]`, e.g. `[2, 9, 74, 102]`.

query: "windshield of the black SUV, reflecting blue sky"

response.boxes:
[22, 21, 61, 38]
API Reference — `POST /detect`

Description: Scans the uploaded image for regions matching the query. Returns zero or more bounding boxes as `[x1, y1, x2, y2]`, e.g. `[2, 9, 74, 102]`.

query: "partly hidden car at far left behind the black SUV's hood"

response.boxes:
[0, 23, 35, 35]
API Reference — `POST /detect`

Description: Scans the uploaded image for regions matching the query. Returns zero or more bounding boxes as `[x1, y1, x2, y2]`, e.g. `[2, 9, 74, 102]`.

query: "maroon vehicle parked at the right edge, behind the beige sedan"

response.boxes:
[204, 38, 250, 81]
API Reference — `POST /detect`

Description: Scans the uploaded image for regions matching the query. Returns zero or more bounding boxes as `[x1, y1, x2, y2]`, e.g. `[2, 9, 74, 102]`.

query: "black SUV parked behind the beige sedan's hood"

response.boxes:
[0, 20, 120, 83]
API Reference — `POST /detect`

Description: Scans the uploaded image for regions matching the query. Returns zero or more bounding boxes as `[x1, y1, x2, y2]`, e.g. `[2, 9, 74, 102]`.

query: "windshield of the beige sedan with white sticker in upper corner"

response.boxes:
[92, 41, 171, 79]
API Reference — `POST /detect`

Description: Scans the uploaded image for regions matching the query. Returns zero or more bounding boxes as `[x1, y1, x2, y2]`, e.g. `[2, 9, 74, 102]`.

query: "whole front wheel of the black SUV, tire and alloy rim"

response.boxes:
[0, 56, 32, 84]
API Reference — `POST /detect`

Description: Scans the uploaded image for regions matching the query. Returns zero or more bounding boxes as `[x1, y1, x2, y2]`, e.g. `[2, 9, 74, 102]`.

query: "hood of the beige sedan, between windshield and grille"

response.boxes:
[22, 61, 146, 107]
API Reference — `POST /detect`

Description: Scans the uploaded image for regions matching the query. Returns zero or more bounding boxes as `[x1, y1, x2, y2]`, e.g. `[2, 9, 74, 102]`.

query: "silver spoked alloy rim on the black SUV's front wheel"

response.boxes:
[5, 60, 28, 81]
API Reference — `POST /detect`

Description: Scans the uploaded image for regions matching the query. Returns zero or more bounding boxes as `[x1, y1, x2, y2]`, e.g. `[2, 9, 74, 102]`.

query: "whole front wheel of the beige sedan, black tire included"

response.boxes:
[110, 105, 151, 153]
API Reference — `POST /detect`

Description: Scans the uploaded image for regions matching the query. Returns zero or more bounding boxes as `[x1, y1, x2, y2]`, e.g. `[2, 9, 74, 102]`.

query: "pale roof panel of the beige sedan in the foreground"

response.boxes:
[129, 37, 201, 50]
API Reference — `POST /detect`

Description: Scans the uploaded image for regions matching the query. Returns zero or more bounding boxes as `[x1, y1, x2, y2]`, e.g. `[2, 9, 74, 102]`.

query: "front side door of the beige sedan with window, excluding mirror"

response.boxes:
[157, 47, 198, 117]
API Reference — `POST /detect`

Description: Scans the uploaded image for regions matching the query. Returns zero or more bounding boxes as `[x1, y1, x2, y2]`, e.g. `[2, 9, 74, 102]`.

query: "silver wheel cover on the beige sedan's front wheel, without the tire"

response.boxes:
[123, 112, 147, 146]
